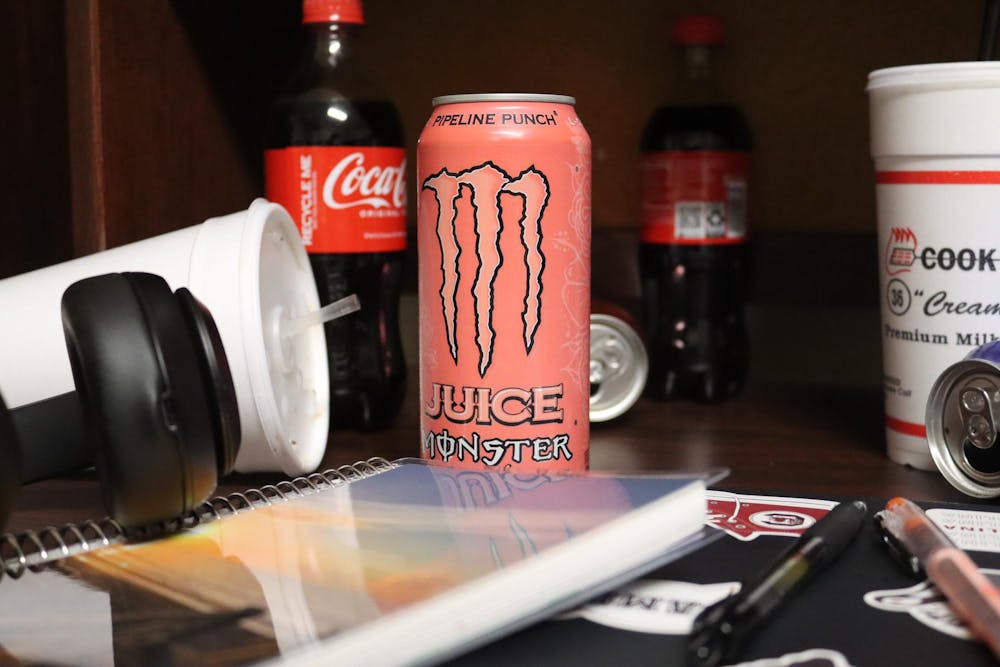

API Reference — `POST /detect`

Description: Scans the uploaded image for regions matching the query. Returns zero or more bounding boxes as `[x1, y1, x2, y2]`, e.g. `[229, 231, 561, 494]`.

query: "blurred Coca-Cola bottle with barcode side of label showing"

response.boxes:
[639, 16, 752, 401]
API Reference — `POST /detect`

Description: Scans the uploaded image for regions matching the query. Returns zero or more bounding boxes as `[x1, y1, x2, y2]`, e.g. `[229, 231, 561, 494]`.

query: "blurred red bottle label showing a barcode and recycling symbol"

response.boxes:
[642, 151, 749, 245]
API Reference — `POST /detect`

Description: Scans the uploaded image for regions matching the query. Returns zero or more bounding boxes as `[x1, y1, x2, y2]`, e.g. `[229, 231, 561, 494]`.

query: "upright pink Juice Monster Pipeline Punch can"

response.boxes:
[417, 93, 590, 472]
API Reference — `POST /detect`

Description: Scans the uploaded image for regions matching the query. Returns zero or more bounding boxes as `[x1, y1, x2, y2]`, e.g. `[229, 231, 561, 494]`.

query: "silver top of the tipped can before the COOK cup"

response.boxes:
[925, 359, 1000, 498]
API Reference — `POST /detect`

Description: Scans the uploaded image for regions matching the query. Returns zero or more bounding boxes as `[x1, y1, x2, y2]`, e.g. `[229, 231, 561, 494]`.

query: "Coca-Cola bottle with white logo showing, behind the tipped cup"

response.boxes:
[265, 0, 406, 430]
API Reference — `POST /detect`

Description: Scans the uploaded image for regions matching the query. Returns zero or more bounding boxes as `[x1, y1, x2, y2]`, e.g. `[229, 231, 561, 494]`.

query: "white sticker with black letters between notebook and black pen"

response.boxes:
[559, 579, 740, 635]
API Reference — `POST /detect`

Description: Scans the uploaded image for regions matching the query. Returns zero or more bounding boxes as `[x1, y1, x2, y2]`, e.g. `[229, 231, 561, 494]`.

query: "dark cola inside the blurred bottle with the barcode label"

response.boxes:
[639, 105, 752, 401]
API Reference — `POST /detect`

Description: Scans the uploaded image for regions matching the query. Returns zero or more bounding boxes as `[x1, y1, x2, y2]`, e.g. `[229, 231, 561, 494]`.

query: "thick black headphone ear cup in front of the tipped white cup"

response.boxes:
[62, 273, 217, 526]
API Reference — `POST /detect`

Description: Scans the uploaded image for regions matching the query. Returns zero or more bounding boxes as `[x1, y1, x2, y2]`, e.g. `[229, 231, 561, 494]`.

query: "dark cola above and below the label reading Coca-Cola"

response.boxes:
[267, 99, 406, 430]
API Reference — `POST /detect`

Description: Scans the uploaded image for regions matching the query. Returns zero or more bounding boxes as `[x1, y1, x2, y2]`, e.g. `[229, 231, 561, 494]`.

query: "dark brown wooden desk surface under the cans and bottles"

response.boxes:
[7, 385, 975, 531]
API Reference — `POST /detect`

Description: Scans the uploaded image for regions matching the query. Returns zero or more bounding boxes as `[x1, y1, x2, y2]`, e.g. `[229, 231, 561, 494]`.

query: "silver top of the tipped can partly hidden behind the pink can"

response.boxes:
[590, 313, 649, 422]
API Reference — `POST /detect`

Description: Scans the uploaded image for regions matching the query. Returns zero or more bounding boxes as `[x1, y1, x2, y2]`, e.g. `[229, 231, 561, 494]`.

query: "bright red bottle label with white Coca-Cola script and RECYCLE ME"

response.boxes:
[264, 146, 406, 253]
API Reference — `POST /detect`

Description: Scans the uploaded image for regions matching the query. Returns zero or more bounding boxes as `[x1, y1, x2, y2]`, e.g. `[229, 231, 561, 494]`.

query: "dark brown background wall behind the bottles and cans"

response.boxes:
[0, 0, 983, 386]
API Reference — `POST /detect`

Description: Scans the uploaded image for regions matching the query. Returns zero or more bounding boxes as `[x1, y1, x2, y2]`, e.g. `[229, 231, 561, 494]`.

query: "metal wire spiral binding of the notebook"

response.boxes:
[0, 457, 396, 579]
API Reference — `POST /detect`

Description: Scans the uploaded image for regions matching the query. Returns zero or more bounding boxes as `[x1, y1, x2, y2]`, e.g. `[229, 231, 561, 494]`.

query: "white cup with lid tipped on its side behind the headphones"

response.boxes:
[0, 199, 330, 475]
